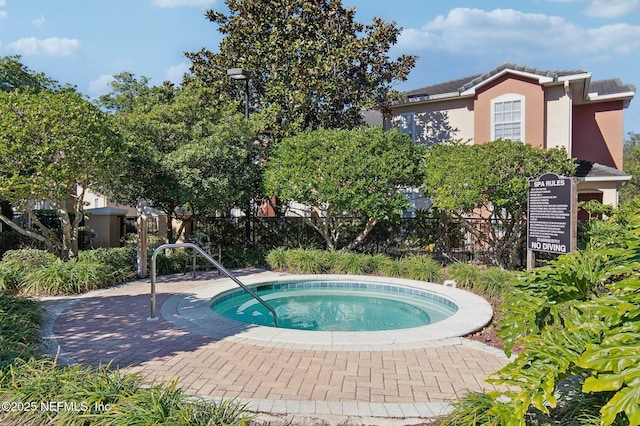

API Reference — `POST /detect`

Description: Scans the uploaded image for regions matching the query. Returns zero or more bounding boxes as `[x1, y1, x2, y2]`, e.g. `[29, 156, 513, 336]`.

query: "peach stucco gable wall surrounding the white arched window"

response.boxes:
[474, 74, 545, 147]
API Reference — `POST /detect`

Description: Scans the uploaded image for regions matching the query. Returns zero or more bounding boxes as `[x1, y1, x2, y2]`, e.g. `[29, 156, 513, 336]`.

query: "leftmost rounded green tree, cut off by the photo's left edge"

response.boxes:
[0, 88, 121, 258]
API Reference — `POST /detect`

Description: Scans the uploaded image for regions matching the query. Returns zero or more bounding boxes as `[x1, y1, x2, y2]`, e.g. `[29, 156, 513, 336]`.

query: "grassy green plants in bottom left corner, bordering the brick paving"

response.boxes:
[0, 359, 251, 426]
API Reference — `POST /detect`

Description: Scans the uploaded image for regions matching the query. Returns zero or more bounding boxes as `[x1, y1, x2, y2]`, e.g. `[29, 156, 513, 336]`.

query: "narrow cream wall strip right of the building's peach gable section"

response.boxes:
[544, 85, 572, 155]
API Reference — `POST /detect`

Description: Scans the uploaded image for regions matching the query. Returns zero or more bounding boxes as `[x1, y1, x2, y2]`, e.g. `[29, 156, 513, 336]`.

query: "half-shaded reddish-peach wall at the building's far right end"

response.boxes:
[571, 101, 624, 170]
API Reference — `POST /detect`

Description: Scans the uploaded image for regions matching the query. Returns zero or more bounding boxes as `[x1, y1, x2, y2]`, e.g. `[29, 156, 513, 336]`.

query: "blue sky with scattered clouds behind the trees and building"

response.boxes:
[0, 0, 640, 133]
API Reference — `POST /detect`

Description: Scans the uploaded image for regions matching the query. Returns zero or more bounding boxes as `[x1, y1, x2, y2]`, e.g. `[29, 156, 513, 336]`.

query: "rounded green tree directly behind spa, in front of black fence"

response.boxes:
[265, 127, 422, 250]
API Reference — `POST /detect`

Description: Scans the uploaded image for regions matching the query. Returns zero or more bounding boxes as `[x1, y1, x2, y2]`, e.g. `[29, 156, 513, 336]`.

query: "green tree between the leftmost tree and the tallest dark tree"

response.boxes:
[100, 73, 267, 242]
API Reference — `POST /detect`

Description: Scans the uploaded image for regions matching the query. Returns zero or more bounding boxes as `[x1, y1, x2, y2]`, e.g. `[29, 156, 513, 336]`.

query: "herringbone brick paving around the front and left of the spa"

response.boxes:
[44, 270, 507, 424]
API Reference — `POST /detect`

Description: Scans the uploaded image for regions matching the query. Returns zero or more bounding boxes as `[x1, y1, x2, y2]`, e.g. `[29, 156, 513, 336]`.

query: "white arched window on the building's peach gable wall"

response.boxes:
[491, 94, 524, 142]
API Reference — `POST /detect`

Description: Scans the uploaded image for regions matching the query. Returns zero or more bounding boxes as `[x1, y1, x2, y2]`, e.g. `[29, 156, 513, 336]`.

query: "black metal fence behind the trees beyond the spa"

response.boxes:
[196, 216, 526, 267]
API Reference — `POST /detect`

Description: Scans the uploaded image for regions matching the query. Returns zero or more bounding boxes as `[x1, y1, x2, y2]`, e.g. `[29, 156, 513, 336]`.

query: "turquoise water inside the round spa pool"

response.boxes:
[211, 281, 458, 331]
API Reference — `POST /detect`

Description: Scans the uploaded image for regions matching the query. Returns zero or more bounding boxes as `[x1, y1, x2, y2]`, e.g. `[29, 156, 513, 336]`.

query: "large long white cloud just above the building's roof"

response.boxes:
[397, 8, 640, 62]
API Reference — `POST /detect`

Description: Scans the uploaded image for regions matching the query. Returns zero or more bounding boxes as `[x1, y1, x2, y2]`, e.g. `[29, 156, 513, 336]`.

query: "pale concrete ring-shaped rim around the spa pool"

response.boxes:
[160, 272, 493, 351]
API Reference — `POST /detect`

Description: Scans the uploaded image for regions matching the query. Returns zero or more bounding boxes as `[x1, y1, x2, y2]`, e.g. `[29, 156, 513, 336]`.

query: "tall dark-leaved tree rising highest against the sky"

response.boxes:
[187, 0, 415, 138]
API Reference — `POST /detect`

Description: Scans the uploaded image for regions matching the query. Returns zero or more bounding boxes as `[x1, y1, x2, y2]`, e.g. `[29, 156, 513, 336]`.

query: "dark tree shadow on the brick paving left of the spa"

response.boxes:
[43, 269, 260, 368]
